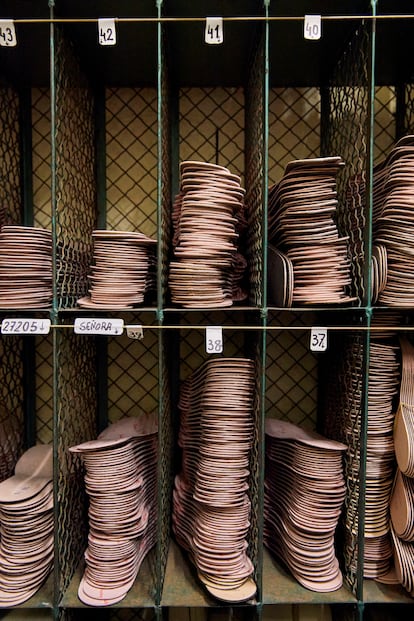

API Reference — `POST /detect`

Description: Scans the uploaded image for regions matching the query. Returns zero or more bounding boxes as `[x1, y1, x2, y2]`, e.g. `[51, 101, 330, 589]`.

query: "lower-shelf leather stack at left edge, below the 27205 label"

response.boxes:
[0, 445, 54, 608]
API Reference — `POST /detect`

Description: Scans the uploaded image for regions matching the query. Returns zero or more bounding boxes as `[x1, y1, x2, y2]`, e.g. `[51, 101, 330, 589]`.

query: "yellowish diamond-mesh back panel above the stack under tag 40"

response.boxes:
[269, 88, 321, 185]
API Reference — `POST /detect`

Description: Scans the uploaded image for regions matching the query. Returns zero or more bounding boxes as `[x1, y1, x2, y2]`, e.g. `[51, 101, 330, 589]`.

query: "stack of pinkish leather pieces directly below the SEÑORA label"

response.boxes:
[70, 414, 157, 606]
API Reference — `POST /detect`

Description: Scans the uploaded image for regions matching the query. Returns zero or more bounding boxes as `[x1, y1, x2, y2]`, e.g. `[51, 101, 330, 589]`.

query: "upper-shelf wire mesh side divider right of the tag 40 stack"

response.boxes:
[322, 26, 370, 305]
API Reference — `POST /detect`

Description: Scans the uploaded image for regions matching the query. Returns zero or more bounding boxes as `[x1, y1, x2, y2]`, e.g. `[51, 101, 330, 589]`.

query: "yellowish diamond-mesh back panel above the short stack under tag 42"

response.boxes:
[106, 88, 157, 238]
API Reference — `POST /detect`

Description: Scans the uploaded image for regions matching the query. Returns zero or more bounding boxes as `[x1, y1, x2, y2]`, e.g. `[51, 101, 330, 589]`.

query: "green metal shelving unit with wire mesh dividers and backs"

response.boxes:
[0, 0, 414, 621]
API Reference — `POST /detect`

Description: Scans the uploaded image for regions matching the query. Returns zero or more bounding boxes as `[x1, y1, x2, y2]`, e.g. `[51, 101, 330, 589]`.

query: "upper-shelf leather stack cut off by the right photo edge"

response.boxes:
[373, 136, 414, 308]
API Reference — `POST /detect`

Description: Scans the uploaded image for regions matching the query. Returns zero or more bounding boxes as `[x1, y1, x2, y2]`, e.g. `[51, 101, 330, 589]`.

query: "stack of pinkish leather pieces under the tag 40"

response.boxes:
[268, 156, 355, 305]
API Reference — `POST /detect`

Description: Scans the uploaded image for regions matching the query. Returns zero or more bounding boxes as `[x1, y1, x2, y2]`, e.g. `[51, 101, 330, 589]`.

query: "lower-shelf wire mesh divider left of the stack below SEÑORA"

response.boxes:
[54, 329, 97, 593]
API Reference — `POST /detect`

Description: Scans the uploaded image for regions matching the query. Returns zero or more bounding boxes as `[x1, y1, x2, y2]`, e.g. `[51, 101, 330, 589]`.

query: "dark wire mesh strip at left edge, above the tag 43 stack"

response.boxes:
[0, 85, 22, 226]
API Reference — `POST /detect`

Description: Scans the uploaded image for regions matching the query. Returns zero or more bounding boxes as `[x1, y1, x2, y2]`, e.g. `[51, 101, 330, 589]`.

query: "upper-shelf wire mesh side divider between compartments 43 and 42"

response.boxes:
[54, 29, 96, 309]
